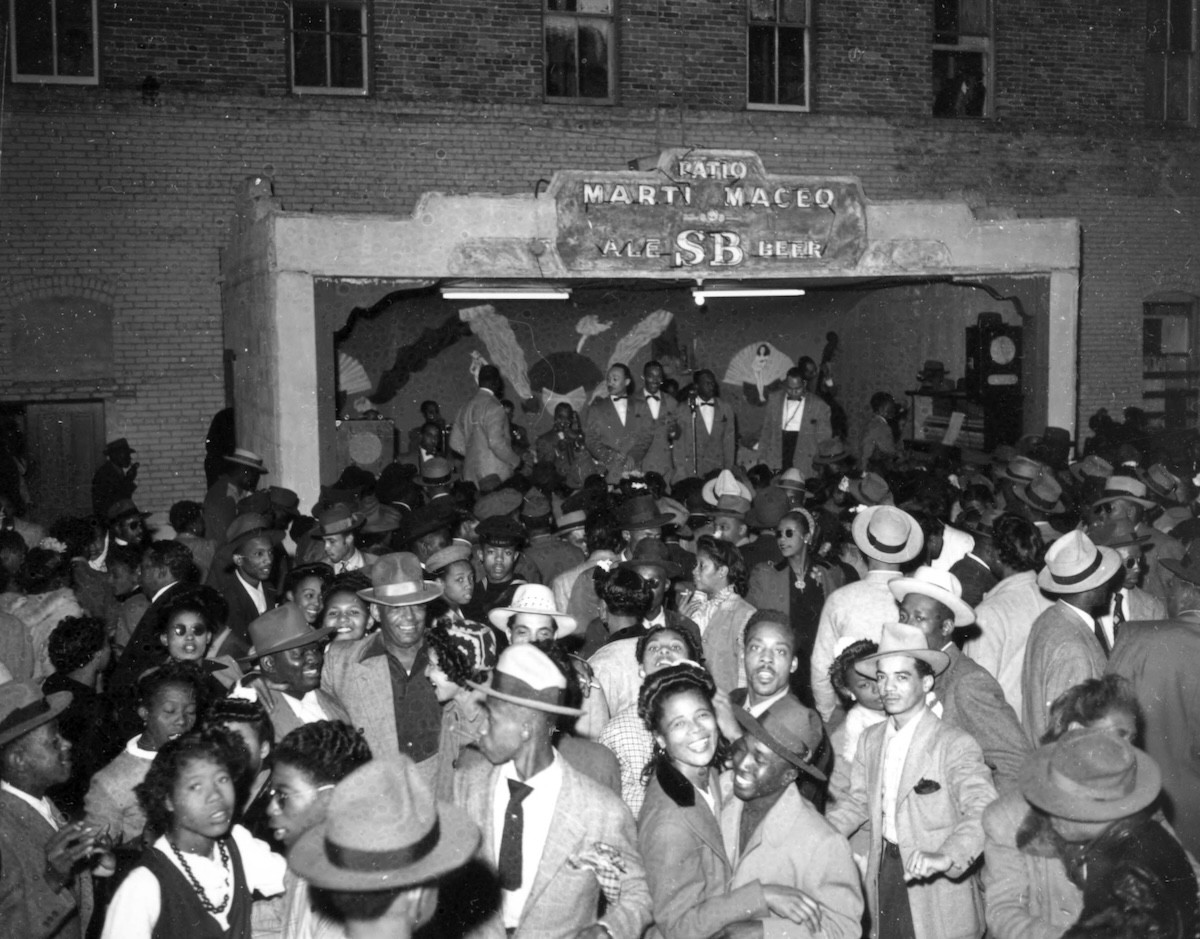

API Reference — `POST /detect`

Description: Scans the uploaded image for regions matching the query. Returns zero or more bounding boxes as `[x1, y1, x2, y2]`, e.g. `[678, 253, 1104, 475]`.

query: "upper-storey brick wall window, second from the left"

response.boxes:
[292, 0, 370, 95]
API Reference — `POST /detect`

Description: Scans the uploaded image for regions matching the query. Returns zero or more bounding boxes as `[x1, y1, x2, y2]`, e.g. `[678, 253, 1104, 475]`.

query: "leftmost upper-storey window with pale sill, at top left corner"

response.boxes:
[8, 0, 100, 85]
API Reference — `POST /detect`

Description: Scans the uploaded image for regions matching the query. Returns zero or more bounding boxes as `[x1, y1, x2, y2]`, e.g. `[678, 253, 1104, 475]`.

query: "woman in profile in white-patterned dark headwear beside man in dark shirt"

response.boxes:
[425, 616, 498, 800]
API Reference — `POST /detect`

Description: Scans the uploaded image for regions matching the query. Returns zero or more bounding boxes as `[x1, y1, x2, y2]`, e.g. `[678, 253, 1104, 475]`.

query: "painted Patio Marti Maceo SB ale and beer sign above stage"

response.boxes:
[548, 149, 866, 277]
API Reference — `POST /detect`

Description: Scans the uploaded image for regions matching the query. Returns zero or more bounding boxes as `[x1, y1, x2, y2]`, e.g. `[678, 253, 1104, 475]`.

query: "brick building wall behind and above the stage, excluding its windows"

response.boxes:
[0, 0, 1200, 509]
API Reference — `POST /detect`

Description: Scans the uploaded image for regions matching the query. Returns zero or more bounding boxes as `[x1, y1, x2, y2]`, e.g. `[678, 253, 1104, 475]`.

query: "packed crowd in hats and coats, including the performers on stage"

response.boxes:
[0, 363, 1200, 939]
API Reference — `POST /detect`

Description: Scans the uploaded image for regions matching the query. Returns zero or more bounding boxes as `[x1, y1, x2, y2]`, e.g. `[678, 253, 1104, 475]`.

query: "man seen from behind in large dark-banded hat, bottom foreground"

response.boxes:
[295, 756, 477, 939]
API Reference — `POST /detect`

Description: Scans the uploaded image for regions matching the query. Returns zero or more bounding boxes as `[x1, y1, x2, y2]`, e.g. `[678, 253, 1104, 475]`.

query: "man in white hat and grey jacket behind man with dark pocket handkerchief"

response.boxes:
[888, 567, 1030, 793]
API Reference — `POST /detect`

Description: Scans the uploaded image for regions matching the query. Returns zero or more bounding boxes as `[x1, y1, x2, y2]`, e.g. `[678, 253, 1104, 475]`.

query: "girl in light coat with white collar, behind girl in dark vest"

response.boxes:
[84, 662, 200, 849]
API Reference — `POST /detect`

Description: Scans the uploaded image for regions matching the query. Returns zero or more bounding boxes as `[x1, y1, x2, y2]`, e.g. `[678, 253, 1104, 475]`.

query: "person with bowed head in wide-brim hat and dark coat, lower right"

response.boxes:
[1021, 730, 1200, 939]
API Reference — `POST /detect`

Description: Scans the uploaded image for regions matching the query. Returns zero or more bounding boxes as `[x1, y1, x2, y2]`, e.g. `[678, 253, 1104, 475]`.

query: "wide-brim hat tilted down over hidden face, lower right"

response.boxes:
[1019, 729, 1163, 821]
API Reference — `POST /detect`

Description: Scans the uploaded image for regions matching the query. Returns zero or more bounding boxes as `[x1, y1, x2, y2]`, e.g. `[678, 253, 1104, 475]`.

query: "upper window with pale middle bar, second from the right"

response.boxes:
[932, 0, 992, 118]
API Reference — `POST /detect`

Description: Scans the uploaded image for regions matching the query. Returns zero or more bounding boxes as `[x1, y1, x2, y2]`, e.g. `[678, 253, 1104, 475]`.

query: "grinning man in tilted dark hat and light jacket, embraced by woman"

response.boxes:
[720, 696, 863, 939]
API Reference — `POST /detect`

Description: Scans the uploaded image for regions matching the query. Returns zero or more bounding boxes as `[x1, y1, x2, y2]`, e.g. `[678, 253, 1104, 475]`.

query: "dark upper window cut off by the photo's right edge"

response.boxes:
[1146, 0, 1196, 122]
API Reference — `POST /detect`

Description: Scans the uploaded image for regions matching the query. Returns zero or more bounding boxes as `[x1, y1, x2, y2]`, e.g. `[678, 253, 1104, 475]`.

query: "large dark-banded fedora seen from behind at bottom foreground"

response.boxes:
[288, 755, 480, 892]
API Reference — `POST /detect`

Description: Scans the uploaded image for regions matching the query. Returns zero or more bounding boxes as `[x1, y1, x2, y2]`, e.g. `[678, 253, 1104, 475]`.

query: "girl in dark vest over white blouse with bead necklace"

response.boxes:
[102, 728, 287, 939]
